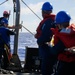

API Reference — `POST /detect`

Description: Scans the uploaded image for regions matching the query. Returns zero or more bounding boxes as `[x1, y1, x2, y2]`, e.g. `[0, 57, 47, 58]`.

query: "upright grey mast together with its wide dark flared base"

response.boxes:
[10, 0, 22, 71]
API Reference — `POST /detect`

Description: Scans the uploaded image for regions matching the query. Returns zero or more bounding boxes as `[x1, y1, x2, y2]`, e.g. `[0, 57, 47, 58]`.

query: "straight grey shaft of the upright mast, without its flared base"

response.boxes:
[13, 0, 20, 54]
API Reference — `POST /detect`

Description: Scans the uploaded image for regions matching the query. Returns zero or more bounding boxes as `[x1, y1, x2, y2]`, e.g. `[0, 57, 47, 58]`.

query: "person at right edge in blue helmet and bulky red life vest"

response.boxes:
[50, 11, 75, 75]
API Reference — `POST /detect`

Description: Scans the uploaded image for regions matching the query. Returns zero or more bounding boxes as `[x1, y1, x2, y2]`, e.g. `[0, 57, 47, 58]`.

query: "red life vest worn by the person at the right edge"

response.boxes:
[52, 24, 75, 62]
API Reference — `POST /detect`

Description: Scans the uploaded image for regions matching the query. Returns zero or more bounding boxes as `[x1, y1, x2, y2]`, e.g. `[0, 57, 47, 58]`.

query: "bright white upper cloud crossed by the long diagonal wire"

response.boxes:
[21, 2, 43, 15]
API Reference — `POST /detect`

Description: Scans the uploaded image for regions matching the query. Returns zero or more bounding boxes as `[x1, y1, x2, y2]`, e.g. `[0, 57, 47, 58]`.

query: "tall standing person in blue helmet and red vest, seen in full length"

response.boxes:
[35, 2, 55, 75]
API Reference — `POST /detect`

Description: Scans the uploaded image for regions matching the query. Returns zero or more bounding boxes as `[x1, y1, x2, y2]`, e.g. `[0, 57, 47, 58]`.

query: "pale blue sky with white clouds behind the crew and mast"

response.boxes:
[0, 0, 75, 33]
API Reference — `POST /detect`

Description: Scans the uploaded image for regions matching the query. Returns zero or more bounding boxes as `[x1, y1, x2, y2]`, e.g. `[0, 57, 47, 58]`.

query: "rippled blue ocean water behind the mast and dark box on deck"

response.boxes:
[10, 33, 38, 61]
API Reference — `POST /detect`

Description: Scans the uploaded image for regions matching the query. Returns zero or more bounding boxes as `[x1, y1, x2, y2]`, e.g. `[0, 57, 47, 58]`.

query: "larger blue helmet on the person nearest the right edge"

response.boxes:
[55, 11, 71, 24]
